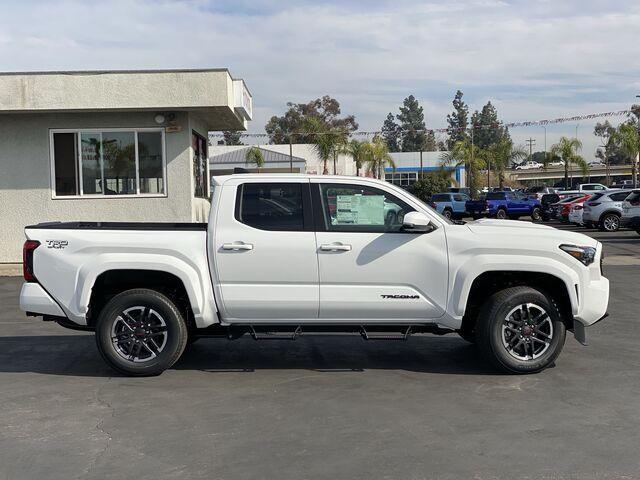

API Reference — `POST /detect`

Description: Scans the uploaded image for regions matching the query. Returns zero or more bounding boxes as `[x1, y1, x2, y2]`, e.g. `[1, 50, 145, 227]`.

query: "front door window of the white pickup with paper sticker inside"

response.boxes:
[320, 184, 414, 233]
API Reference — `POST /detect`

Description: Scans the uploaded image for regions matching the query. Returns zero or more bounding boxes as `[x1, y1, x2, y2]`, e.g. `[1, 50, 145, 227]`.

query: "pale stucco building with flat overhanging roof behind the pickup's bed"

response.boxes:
[0, 69, 252, 263]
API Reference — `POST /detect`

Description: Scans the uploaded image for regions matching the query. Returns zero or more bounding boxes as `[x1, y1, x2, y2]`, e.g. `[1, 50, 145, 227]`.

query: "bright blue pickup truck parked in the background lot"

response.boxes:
[465, 192, 542, 222]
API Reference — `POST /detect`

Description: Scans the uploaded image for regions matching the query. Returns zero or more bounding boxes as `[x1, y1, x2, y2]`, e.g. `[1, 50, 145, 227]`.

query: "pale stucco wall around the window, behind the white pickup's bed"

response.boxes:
[0, 112, 198, 263]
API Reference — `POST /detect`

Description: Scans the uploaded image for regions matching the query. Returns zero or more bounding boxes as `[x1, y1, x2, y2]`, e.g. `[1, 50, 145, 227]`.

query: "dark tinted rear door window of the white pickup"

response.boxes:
[236, 183, 304, 231]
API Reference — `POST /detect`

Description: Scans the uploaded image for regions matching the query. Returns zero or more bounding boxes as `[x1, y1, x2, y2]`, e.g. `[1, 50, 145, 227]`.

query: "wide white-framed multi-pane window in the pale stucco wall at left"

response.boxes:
[51, 129, 166, 197]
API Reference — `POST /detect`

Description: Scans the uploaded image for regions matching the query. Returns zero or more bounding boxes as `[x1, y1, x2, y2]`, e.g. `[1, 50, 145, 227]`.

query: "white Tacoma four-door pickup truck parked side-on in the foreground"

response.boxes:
[20, 174, 609, 375]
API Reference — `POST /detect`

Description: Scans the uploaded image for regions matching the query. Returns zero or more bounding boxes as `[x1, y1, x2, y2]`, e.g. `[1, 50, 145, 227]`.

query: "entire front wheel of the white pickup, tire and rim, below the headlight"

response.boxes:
[476, 287, 566, 373]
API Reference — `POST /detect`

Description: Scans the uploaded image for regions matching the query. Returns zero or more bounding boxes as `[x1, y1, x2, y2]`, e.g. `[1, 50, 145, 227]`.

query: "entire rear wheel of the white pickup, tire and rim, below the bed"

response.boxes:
[96, 289, 188, 376]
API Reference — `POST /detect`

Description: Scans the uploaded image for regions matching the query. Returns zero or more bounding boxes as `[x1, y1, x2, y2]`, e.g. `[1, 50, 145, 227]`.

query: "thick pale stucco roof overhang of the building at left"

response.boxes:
[0, 69, 253, 130]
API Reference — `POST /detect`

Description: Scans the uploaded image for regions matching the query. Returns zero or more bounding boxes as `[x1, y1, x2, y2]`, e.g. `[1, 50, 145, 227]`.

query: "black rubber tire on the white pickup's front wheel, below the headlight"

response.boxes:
[476, 287, 566, 373]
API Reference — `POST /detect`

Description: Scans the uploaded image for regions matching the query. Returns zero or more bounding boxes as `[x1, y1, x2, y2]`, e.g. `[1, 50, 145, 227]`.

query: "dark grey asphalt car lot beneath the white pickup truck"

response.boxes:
[0, 225, 640, 479]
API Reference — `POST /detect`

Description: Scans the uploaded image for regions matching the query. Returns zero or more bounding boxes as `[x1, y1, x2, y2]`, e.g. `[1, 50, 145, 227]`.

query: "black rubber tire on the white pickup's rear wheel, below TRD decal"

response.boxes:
[96, 289, 189, 377]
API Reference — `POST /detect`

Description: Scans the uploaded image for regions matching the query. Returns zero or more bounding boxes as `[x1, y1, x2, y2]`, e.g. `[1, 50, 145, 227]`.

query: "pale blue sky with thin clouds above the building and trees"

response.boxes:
[0, 0, 640, 159]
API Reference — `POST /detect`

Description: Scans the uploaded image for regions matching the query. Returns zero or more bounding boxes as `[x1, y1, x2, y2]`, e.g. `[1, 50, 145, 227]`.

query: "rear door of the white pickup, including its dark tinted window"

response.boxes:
[211, 179, 319, 323]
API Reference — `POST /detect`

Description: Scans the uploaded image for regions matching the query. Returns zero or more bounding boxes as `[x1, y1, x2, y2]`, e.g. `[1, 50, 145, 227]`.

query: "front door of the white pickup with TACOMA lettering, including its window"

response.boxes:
[312, 179, 448, 322]
